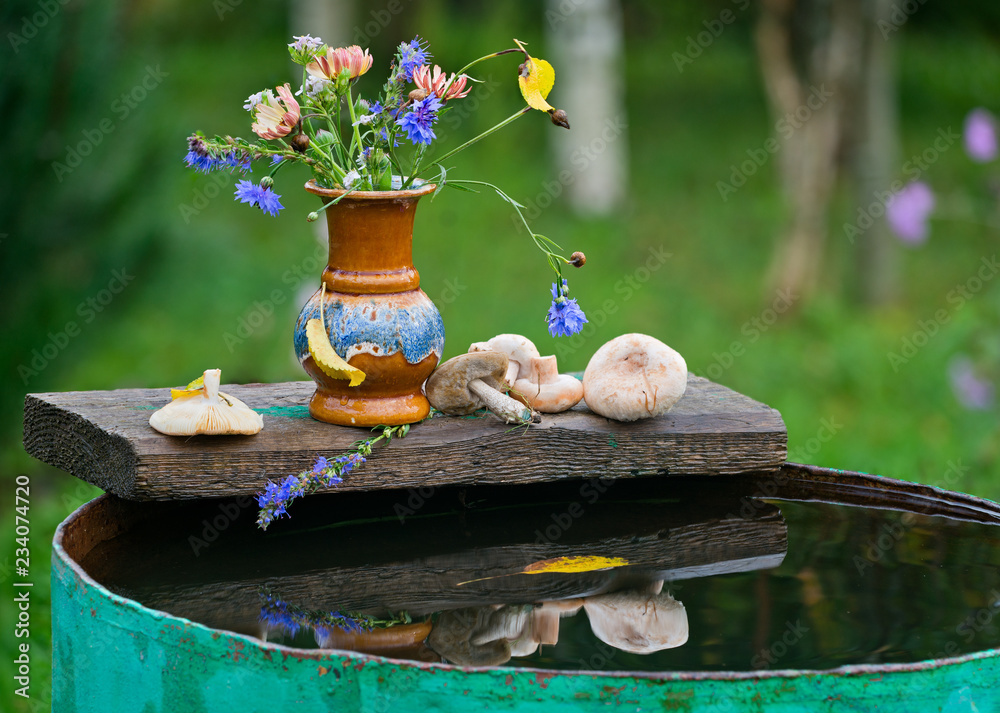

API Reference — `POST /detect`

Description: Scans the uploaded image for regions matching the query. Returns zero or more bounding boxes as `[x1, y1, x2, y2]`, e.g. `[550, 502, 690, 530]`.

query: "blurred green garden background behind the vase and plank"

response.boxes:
[0, 0, 1000, 710]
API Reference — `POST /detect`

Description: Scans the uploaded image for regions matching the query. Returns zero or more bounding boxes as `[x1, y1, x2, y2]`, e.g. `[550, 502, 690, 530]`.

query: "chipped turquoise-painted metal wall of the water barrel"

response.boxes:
[52, 469, 1000, 713]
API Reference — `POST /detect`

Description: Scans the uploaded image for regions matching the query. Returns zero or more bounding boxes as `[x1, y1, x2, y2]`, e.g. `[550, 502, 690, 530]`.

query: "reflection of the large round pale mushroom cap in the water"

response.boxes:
[583, 592, 688, 654]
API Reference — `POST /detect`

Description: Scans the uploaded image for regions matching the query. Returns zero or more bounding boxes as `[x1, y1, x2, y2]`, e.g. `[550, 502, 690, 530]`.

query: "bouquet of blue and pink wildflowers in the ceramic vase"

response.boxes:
[185, 35, 587, 336]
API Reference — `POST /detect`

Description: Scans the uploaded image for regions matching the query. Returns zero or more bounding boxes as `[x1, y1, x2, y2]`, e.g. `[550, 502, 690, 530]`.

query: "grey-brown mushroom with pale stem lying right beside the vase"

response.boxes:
[425, 351, 537, 423]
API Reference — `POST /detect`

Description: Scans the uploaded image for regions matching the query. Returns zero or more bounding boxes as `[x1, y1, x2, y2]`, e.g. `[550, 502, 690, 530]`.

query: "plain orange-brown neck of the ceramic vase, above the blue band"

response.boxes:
[323, 193, 420, 294]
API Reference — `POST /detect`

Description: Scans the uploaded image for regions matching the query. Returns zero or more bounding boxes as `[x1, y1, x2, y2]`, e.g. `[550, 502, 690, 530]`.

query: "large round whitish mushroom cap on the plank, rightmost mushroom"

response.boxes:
[583, 334, 687, 421]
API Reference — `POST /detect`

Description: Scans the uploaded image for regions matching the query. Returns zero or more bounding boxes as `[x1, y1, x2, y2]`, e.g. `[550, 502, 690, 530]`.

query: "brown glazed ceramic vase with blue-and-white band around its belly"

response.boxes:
[295, 181, 444, 427]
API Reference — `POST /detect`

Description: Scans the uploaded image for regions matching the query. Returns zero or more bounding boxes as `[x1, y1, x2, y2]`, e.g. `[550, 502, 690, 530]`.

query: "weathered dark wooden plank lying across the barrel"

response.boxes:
[24, 376, 787, 500]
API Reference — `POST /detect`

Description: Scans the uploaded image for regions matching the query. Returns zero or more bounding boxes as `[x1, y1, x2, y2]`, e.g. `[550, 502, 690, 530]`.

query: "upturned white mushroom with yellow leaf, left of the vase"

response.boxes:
[149, 369, 264, 436]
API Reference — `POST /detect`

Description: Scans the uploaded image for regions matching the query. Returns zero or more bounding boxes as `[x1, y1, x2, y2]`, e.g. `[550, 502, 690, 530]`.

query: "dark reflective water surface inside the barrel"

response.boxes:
[82, 476, 1000, 671]
